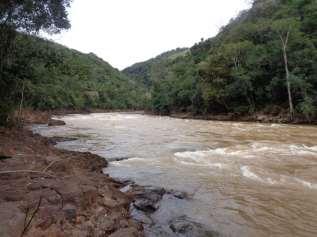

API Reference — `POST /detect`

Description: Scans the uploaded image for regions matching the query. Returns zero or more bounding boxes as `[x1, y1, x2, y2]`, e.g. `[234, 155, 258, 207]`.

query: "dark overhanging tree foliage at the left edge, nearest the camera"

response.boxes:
[0, 0, 70, 125]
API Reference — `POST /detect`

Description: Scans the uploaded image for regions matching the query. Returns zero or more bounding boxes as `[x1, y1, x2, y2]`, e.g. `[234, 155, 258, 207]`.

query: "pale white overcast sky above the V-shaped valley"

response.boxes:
[50, 0, 249, 69]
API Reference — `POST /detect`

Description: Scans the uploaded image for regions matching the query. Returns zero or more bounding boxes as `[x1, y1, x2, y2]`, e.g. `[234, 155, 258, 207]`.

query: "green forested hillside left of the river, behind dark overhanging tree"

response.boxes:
[1, 34, 145, 125]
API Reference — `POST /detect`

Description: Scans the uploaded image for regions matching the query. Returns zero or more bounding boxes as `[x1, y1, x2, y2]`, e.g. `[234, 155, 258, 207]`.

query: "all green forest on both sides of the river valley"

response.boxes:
[0, 0, 317, 124]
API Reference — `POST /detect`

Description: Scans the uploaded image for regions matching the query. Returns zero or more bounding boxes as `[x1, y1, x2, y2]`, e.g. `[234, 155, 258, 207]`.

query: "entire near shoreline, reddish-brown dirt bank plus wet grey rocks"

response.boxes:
[0, 112, 214, 237]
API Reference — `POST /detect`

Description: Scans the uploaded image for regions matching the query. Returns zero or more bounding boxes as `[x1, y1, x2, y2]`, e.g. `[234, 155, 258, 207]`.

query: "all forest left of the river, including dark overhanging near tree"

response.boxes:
[0, 0, 146, 124]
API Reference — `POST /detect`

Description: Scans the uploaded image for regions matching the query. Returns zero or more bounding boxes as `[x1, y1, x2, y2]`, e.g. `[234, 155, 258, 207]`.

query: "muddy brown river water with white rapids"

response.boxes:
[33, 113, 317, 236]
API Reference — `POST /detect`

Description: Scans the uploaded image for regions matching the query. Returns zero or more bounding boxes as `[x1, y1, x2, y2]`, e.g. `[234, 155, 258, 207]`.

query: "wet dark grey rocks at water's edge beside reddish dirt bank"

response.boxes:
[120, 181, 220, 237]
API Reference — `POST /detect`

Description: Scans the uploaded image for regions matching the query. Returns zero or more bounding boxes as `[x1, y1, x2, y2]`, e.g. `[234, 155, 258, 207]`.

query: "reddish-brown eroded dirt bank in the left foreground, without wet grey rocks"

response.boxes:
[0, 128, 143, 237]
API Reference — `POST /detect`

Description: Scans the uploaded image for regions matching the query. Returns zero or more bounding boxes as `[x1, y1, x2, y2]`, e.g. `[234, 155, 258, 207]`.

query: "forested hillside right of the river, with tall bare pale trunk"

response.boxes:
[124, 0, 317, 120]
